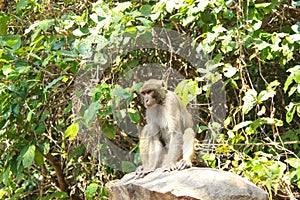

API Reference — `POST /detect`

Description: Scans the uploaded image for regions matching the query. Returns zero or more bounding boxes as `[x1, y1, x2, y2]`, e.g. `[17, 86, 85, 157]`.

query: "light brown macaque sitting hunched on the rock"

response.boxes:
[136, 79, 195, 178]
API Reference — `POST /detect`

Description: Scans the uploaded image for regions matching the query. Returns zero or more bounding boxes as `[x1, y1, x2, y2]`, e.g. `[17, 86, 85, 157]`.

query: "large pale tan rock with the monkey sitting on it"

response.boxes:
[106, 167, 268, 200]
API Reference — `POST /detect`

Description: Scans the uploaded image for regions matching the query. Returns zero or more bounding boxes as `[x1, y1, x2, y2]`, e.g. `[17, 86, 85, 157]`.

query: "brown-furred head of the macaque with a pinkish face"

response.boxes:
[141, 79, 167, 108]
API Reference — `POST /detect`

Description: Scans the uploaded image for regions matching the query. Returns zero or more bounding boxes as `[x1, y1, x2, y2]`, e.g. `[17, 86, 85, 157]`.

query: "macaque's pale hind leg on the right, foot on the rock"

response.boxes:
[176, 128, 195, 170]
